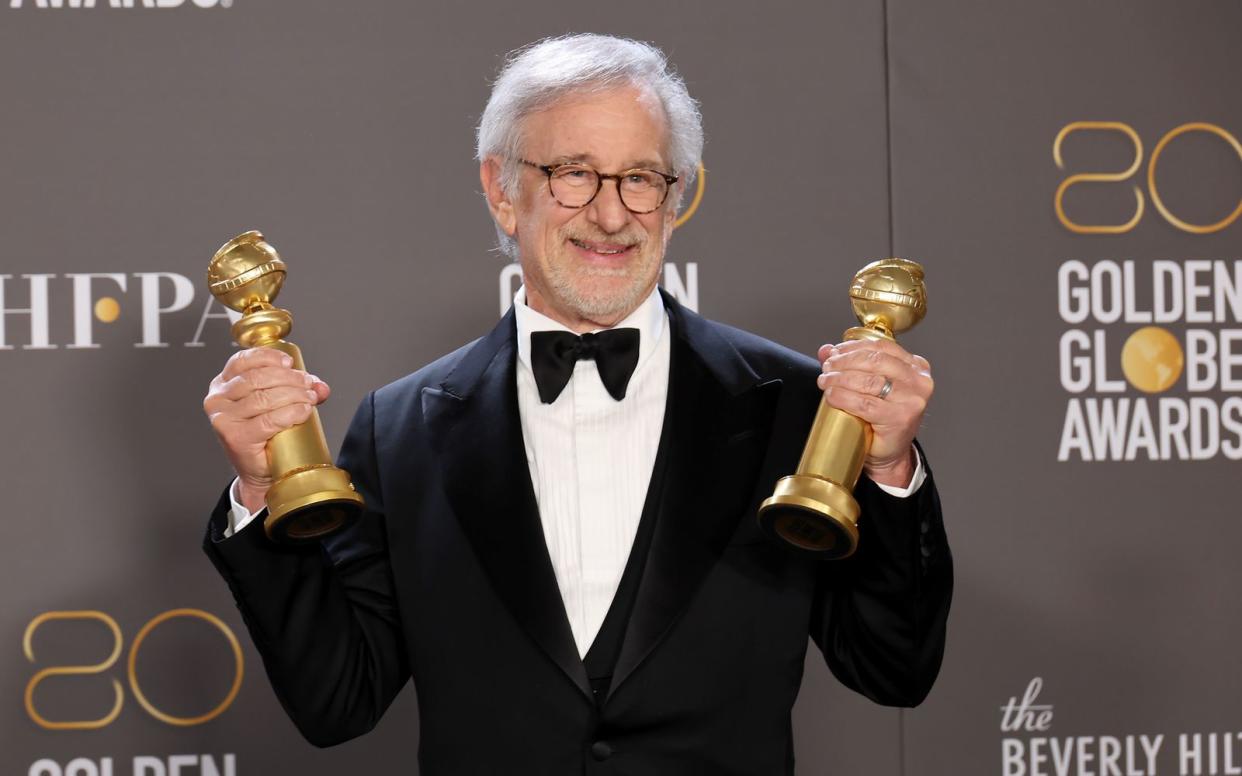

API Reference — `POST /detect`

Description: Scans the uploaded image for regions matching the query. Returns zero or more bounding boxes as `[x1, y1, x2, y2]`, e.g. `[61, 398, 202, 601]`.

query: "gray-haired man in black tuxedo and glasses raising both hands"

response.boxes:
[204, 35, 951, 776]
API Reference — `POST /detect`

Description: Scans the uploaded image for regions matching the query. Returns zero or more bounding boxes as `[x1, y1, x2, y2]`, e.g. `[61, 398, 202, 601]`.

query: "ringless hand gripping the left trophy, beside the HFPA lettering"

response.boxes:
[202, 348, 332, 513]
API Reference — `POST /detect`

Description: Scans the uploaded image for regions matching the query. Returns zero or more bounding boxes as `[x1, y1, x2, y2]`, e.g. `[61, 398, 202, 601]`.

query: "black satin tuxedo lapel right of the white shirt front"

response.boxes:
[609, 294, 780, 695]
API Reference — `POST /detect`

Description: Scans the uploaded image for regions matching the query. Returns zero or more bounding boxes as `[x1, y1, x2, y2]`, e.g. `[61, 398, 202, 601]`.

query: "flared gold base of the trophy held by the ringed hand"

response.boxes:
[759, 474, 858, 559]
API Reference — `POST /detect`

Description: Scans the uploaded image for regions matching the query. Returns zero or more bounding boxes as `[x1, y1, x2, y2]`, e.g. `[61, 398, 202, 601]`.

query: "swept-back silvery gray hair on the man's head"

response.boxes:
[476, 35, 703, 258]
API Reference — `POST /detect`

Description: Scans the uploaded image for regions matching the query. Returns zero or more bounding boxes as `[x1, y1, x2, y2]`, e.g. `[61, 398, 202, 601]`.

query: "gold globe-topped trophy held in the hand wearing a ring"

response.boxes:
[759, 258, 927, 559]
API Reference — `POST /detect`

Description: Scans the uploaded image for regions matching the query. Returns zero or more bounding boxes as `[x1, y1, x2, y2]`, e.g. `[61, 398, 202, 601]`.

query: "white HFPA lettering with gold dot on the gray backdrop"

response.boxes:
[0, 272, 241, 350]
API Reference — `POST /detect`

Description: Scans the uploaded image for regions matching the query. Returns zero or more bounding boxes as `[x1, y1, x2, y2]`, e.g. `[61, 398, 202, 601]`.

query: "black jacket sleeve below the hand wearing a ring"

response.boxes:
[811, 448, 953, 706]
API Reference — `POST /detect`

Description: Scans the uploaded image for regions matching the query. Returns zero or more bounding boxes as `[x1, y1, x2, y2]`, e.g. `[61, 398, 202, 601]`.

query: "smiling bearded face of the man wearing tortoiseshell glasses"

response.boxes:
[481, 88, 676, 332]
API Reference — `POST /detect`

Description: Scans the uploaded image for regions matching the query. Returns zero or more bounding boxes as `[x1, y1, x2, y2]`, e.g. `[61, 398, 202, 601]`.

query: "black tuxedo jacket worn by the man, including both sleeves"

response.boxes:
[205, 288, 953, 776]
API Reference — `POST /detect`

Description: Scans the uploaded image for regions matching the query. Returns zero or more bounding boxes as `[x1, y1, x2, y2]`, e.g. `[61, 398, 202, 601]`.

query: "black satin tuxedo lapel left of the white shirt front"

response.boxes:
[422, 309, 591, 698]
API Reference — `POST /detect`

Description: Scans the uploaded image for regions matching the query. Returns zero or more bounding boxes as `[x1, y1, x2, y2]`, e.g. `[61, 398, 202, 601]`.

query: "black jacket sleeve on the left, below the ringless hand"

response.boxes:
[204, 396, 410, 746]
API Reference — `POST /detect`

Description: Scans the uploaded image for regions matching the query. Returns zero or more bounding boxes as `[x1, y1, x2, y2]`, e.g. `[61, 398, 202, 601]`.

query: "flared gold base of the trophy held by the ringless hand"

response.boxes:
[263, 464, 363, 543]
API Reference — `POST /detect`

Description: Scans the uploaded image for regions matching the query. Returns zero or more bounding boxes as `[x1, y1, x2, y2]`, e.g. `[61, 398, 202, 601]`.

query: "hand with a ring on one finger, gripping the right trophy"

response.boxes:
[818, 340, 934, 488]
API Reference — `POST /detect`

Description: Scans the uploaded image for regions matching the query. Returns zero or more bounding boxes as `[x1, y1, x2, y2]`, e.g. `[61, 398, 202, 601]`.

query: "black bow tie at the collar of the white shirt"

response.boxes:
[530, 329, 638, 405]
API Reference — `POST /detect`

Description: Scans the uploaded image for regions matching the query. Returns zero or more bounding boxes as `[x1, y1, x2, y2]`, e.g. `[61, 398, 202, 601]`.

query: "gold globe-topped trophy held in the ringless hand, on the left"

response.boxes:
[207, 231, 363, 541]
